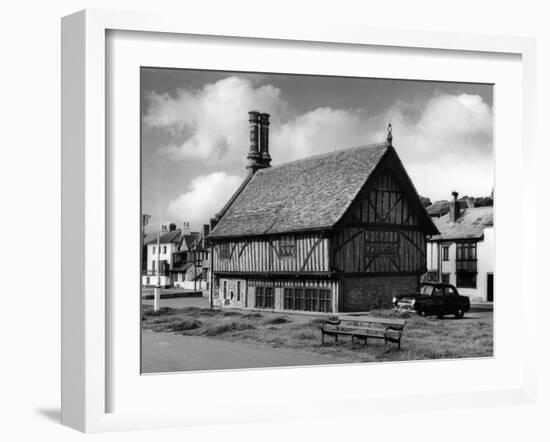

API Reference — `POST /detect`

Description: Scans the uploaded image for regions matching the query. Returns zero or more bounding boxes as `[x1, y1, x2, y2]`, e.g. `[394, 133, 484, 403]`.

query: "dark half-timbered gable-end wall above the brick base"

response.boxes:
[332, 169, 426, 274]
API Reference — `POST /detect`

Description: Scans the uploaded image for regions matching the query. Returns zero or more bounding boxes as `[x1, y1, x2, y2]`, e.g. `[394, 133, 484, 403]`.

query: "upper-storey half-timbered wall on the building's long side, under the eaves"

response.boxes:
[213, 234, 329, 274]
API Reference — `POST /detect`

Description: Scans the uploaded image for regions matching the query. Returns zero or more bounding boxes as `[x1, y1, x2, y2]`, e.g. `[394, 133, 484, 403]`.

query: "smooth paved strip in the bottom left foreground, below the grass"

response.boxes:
[142, 330, 335, 373]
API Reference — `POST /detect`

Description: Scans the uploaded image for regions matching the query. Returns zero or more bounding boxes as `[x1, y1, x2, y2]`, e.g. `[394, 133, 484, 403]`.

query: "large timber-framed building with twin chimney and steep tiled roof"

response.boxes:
[208, 112, 438, 313]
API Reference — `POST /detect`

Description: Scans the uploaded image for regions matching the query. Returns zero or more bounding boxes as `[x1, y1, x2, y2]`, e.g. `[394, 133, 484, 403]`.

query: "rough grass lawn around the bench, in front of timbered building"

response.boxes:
[142, 305, 493, 362]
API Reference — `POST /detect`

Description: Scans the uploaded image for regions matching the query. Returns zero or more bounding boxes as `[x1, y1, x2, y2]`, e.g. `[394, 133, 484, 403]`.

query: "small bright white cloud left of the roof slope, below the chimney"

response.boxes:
[168, 172, 242, 228]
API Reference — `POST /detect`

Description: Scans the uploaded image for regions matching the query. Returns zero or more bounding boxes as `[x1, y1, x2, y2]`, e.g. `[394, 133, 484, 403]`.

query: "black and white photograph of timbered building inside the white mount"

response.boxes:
[139, 67, 497, 373]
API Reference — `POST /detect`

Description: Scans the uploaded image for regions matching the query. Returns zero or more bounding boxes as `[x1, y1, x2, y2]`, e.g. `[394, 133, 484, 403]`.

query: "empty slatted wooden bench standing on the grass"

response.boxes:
[321, 316, 406, 351]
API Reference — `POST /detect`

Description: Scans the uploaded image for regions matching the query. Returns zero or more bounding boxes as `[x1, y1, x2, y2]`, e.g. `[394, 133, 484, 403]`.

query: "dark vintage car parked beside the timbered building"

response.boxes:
[393, 282, 470, 318]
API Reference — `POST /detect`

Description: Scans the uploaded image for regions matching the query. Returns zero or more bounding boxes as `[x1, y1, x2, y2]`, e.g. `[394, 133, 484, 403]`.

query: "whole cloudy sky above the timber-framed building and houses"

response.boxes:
[141, 68, 493, 230]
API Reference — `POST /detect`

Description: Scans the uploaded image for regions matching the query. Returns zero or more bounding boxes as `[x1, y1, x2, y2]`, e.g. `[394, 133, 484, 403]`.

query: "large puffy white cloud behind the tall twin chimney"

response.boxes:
[144, 77, 288, 162]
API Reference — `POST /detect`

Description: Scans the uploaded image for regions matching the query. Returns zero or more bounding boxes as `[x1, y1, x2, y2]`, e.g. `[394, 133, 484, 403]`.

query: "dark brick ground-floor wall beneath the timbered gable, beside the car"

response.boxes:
[343, 276, 418, 312]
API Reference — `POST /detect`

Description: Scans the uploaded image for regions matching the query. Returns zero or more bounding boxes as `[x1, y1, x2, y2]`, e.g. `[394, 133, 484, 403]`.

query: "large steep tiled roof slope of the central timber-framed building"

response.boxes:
[209, 143, 434, 238]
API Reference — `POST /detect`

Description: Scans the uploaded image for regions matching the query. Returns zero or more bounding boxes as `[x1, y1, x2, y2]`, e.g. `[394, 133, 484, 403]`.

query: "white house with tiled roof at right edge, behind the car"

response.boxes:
[426, 192, 494, 302]
